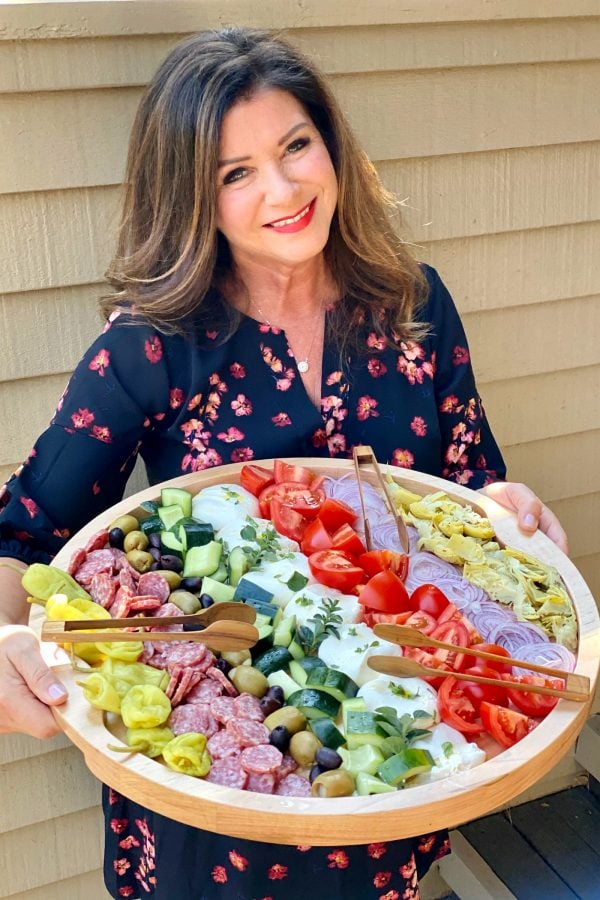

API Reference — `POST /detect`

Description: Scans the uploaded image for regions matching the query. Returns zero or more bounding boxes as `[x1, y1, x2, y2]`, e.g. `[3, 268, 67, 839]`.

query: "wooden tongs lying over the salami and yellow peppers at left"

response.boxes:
[41, 602, 258, 651]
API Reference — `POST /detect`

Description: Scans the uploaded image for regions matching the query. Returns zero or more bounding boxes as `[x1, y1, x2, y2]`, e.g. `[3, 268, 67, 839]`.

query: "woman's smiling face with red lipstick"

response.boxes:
[217, 89, 337, 270]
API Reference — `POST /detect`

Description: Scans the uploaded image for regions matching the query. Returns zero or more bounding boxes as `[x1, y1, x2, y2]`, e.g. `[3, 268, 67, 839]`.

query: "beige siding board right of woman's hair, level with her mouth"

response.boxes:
[377, 142, 600, 243]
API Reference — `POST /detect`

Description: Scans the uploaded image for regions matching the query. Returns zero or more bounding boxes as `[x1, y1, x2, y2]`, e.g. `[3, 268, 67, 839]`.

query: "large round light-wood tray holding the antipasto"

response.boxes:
[48, 459, 600, 846]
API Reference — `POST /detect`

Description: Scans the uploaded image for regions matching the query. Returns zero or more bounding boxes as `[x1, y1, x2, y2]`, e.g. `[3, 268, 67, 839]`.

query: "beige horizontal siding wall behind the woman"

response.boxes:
[0, 0, 600, 900]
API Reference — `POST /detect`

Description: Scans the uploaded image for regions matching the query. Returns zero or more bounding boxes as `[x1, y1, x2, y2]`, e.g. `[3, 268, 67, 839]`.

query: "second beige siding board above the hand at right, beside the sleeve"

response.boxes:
[479, 368, 600, 447]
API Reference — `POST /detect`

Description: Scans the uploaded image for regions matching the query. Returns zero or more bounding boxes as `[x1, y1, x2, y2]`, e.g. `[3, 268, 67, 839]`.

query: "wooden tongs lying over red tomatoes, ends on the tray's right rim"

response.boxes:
[367, 624, 590, 703]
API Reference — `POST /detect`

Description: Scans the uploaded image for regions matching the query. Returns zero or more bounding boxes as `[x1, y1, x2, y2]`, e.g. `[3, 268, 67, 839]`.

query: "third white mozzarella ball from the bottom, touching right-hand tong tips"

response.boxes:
[319, 623, 402, 687]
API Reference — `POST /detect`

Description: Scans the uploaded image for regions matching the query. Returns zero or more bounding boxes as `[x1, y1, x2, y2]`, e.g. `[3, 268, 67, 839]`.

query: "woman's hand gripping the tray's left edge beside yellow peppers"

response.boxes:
[0, 625, 67, 738]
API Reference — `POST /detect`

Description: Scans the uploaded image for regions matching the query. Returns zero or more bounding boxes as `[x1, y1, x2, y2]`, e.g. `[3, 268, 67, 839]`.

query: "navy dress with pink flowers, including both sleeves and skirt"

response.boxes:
[0, 267, 505, 900]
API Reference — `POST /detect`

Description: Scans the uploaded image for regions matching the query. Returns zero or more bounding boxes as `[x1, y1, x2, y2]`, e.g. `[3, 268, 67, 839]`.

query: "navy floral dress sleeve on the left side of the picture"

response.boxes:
[0, 316, 169, 563]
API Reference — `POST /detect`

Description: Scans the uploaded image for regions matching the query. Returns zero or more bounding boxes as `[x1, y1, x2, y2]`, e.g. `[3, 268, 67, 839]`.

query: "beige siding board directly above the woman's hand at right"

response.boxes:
[504, 423, 600, 502]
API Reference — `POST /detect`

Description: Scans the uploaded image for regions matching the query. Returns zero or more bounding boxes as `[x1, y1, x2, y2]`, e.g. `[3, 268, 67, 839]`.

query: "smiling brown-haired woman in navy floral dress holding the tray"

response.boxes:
[0, 29, 566, 900]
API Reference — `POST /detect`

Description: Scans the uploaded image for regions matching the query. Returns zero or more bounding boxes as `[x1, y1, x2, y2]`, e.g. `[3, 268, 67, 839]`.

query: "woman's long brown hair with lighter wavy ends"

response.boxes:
[102, 28, 426, 346]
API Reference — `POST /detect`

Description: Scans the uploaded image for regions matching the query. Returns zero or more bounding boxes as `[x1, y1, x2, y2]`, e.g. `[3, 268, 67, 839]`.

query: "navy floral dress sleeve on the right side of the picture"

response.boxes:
[425, 267, 506, 489]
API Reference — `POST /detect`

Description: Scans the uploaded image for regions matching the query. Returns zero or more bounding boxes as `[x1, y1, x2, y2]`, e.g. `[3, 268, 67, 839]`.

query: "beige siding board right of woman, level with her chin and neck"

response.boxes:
[419, 222, 600, 315]
